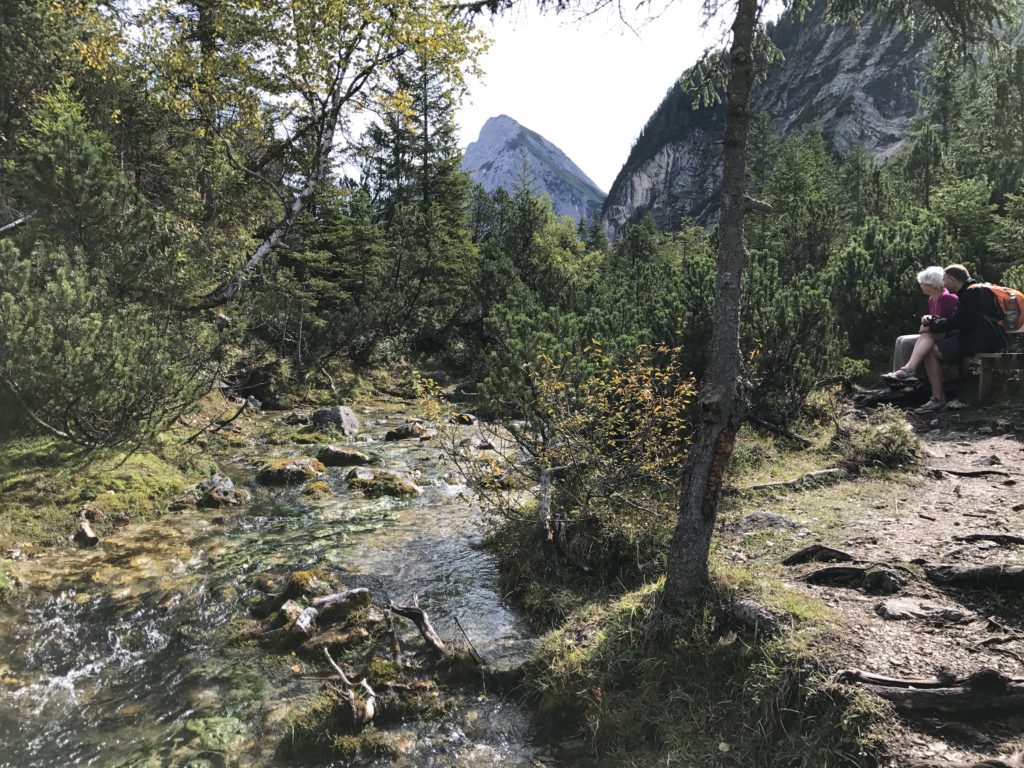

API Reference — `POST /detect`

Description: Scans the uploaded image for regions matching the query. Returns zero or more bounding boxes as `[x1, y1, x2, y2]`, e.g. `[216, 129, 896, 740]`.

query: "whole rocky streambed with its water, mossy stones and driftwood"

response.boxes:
[0, 402, 541, 768]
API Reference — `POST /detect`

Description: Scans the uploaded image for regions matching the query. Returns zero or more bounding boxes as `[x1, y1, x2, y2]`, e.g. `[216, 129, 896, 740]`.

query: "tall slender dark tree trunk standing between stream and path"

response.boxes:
[664, 0, 758, 614]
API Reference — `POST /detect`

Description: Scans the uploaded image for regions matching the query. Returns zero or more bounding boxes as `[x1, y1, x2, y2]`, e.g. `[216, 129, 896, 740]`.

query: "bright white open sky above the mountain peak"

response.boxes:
[458, 0, 737, 193]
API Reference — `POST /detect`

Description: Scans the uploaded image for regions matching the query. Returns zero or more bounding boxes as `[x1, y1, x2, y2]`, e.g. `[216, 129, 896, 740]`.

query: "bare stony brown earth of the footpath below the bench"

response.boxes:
[726, 409, 1024, 765]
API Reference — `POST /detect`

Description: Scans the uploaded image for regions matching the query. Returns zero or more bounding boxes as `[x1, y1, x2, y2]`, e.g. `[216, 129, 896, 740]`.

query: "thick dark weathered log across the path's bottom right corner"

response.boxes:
[839, 670, 1024, 717]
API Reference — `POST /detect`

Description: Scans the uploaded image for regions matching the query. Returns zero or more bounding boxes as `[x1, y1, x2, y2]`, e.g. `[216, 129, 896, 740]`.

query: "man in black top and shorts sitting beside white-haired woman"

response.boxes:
[883, 264, 1009, 414]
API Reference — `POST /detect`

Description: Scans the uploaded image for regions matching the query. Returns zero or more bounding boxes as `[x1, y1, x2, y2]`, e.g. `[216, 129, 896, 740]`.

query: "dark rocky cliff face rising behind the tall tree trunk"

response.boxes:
[602, 8, 928, 238]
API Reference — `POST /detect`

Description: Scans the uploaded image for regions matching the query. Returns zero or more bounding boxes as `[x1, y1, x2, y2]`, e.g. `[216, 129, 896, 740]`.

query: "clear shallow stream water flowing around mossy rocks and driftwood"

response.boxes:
[0, 403, 541, 768]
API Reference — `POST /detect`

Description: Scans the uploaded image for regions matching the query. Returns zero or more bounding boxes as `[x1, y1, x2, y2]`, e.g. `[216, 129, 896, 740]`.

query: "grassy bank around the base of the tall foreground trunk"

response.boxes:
[483, 413, 919, 768]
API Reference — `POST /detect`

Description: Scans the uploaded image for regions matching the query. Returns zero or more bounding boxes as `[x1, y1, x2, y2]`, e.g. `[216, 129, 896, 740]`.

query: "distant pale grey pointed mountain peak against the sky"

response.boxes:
[462, 115, 604, 218]
